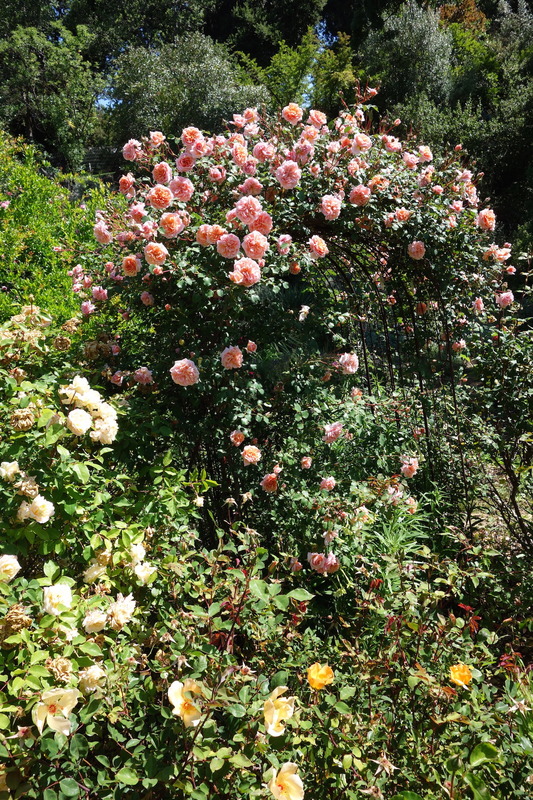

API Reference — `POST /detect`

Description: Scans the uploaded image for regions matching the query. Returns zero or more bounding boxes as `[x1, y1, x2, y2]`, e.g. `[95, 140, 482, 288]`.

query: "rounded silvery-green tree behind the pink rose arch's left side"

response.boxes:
[110, 33, 268, 140]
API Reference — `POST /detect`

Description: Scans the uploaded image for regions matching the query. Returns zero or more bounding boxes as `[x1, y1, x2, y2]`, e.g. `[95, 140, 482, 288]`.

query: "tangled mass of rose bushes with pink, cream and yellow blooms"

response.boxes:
[0, 89, 533, 800]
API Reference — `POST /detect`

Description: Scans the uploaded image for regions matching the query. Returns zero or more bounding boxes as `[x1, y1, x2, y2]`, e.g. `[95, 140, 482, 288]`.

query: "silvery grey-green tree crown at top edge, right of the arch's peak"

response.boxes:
[361, 0, 453, 104]
